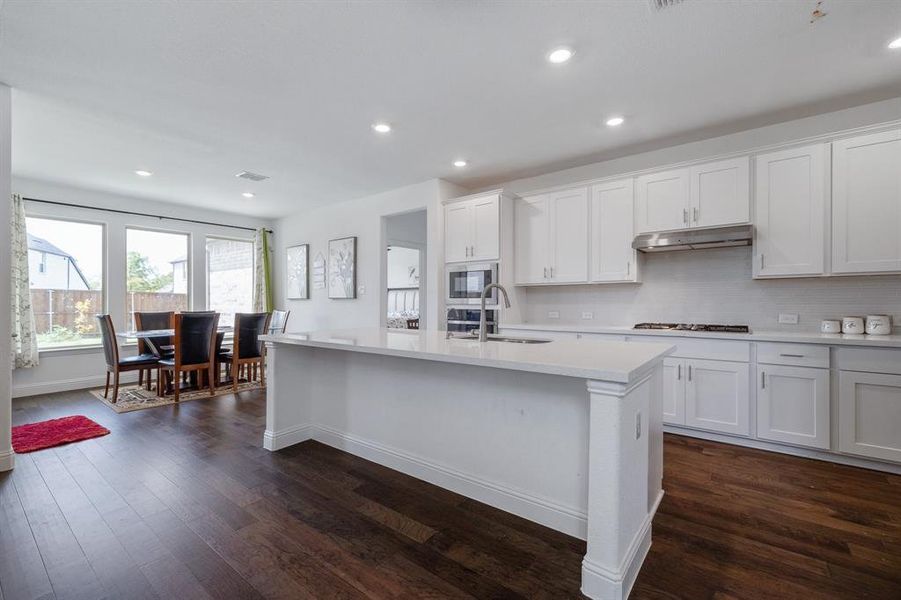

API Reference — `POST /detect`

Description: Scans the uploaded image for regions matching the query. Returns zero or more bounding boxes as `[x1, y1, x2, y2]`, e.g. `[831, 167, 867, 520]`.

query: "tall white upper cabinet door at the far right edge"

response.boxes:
[832, 129, 901, 273]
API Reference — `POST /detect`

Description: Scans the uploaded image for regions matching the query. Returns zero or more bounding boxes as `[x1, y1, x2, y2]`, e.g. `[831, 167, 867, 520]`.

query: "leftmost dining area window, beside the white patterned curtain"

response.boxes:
[25, 217, 103, 348]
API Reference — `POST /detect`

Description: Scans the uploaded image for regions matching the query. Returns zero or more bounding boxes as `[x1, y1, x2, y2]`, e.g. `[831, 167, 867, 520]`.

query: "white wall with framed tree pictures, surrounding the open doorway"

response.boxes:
[274, 179, 465, 331]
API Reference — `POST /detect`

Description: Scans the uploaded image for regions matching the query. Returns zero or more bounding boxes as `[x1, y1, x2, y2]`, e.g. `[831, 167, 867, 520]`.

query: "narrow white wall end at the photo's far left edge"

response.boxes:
[0, 84, 14, 471]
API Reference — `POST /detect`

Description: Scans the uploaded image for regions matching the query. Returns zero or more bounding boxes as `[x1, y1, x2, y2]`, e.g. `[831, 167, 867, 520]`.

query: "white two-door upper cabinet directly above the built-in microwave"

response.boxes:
[444, 193, 500, 262]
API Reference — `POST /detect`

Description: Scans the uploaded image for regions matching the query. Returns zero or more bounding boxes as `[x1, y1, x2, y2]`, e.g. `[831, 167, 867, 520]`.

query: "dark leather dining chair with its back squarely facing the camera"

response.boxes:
[157, 312, 219, 402]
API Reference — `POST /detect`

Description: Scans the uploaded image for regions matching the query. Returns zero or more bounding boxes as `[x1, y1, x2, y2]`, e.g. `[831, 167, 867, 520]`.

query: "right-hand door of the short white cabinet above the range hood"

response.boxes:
[689, 156, 751, 227]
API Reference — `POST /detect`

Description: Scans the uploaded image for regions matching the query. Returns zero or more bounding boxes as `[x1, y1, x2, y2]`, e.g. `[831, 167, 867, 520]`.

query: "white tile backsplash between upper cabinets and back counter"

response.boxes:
[521, 247, 901, 331]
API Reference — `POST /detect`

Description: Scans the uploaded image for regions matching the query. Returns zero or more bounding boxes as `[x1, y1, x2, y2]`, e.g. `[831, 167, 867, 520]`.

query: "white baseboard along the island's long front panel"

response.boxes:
[313, 425, 588, 540]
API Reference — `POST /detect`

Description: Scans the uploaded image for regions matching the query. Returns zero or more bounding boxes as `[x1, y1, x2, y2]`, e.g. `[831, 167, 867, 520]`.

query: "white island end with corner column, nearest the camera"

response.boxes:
[582, 361, 663, 600]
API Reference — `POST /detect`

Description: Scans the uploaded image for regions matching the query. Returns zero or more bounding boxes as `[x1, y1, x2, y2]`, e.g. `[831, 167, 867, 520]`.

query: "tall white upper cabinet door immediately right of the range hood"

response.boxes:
[754, 144, 827, 278]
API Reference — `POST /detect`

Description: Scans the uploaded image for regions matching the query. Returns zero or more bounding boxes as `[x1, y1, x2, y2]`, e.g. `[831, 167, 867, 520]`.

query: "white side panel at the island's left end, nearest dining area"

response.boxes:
[263, 342, 315, 450]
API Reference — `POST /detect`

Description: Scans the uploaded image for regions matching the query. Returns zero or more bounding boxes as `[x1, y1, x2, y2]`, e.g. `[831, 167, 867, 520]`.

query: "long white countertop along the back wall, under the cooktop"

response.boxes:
[500, 323, 901, 348]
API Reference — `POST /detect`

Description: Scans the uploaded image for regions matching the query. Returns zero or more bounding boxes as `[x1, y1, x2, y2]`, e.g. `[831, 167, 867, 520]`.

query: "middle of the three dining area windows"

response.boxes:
[125, 228, 190, 329]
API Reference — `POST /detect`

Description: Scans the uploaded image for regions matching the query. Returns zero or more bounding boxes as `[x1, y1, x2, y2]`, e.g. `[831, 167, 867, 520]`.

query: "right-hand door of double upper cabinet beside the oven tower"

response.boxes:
[548, 188, 589, 283]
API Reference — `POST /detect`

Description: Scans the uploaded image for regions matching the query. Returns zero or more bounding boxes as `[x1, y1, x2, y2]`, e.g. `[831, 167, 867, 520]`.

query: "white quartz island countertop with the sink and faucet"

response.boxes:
[260, 328, 674, 383]
